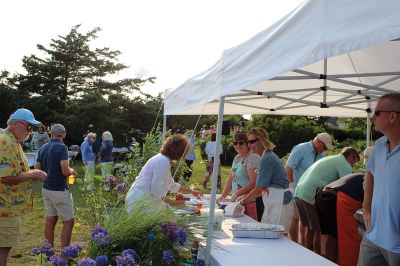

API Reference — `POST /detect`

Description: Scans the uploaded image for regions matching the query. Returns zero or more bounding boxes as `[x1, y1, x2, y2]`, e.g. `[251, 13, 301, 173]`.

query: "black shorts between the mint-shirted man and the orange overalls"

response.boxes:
[315, 191, 337, 238]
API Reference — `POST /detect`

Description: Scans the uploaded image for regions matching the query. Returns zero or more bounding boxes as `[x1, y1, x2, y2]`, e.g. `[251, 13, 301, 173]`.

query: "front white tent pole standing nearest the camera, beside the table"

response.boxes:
[206, 96, 225, 265]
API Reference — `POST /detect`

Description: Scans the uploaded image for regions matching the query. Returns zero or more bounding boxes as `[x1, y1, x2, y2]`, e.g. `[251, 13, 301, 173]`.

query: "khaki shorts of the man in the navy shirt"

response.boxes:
[42, 188, 74, 221]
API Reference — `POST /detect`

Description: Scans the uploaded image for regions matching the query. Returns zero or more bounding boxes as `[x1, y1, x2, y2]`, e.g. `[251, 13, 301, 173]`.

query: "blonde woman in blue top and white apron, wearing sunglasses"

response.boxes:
[234, 128, 293, 229]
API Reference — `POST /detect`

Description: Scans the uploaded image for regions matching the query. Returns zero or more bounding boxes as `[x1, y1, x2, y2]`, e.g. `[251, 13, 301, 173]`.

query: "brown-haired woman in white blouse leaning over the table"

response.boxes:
[125, 134, 201, 211]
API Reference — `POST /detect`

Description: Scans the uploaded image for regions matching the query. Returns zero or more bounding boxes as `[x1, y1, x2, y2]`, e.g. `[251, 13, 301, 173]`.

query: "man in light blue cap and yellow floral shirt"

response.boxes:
[0, 108, 47, 265]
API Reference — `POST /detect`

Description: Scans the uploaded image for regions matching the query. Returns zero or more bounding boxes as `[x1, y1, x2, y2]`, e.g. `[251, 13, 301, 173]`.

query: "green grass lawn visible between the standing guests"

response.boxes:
[8, 150, 230, 266]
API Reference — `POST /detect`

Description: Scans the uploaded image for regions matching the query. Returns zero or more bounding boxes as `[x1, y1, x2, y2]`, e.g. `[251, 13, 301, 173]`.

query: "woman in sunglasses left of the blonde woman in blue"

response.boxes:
[217, 131, 261, 220]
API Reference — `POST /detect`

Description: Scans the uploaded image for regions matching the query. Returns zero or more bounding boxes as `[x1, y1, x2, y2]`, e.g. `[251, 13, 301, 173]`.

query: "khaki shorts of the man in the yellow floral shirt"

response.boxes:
[0, 216, 21, 248]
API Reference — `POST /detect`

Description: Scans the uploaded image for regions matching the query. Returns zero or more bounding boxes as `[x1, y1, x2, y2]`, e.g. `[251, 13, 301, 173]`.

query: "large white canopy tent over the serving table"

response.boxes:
[164, 0, 400, 262]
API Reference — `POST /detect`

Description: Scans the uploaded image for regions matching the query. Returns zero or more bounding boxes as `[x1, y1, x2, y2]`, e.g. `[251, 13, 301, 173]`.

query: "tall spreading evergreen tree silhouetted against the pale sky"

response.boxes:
[17, 25, 154, 122]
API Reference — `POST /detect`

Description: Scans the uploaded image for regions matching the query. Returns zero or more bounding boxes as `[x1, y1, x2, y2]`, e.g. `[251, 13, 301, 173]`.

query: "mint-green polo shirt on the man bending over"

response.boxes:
[294, 154, 352, 205]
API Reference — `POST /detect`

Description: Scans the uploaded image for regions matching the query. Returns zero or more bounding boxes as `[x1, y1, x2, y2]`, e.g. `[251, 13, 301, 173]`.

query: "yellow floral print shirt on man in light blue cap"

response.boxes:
[0, 129, 33, 217]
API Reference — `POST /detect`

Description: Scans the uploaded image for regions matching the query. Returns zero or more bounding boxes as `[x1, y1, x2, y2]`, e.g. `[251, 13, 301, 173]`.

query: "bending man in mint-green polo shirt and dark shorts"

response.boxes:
[294, 147, 360, 254]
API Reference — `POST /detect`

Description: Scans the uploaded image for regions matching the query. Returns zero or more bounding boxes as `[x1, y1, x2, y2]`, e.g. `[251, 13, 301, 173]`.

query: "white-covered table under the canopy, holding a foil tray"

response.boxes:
[198, 216, 336, 266]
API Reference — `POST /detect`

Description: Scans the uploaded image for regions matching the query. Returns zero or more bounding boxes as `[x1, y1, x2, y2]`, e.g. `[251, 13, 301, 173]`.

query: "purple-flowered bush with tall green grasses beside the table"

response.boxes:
[33, 130, 202, 266]
